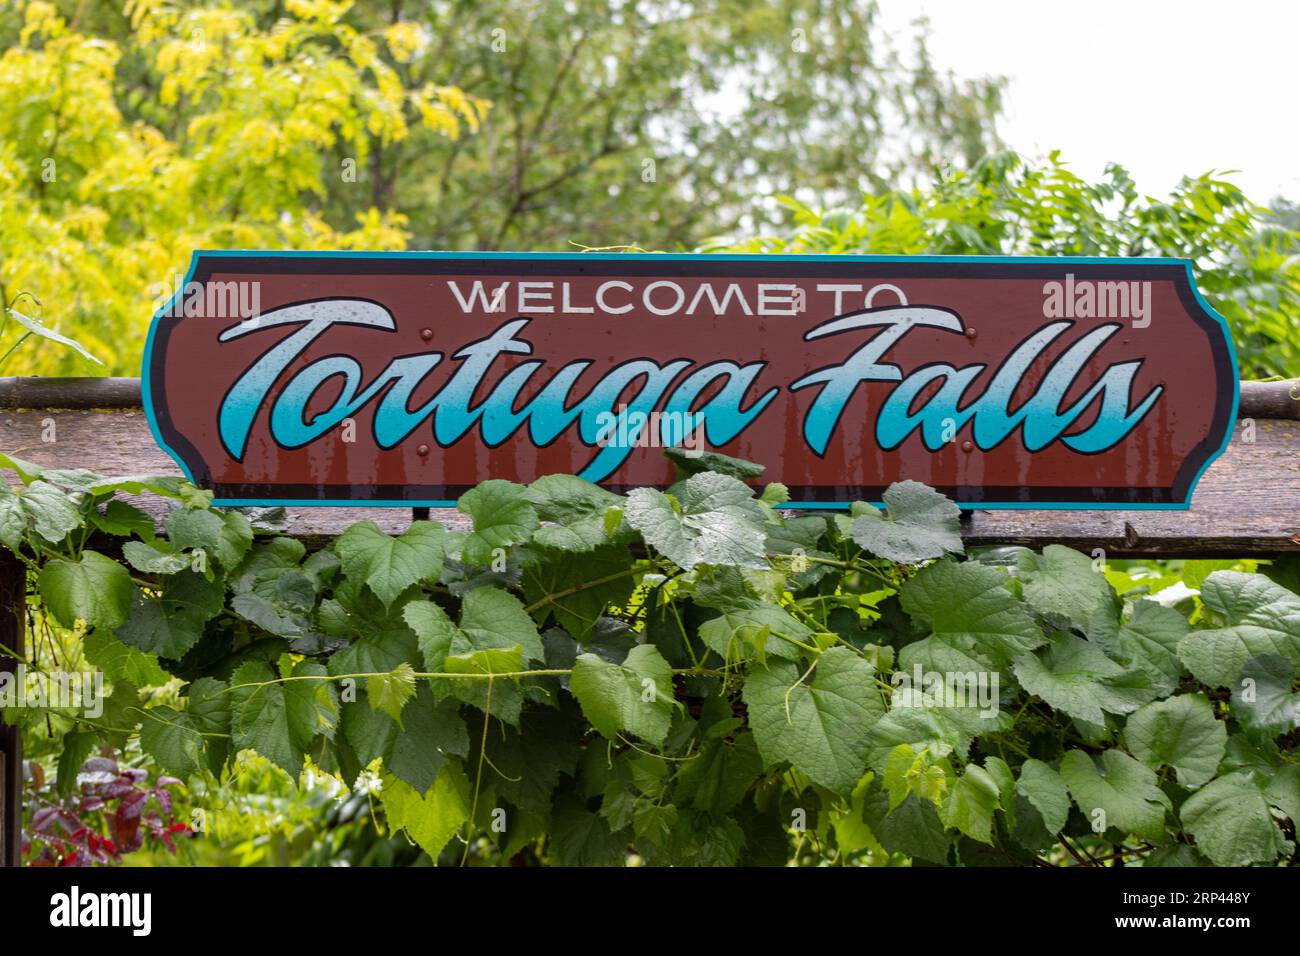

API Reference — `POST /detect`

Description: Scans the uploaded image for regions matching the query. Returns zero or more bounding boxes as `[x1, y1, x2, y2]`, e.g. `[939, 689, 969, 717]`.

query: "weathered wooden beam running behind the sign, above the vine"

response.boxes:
[0, 378, 1300, 558]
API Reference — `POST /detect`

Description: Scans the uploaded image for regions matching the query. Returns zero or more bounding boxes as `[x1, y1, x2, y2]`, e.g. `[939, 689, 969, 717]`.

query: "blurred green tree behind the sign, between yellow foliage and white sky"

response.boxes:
[322, 0, 1002, 250]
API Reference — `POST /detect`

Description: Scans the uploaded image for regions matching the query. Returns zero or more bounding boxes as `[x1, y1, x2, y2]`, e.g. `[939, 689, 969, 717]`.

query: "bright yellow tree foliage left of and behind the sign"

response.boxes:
[0, 0, 486, 375]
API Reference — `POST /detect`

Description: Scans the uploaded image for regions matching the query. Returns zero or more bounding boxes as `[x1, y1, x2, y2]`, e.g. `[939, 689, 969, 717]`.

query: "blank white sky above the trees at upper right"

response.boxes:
[880, 0, 1300, 203]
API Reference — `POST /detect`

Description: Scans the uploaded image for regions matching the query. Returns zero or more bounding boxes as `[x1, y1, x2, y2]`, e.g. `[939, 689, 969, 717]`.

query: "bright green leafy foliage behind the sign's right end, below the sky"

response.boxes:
[717, 152, 1300, 377]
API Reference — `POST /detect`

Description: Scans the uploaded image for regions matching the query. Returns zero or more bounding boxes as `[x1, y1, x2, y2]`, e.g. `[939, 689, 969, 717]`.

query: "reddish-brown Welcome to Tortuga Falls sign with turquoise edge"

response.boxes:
[143, 252, 1238, 507]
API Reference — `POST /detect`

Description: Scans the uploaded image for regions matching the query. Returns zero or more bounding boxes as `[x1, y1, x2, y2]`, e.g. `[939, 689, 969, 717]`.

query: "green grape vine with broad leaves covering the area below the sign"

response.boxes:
[0, 453, 1300, 866]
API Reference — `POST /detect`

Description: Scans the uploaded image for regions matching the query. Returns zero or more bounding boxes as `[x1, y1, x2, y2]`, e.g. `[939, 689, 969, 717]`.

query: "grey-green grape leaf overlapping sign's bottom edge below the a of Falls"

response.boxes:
[852, 481, 965, 564]
